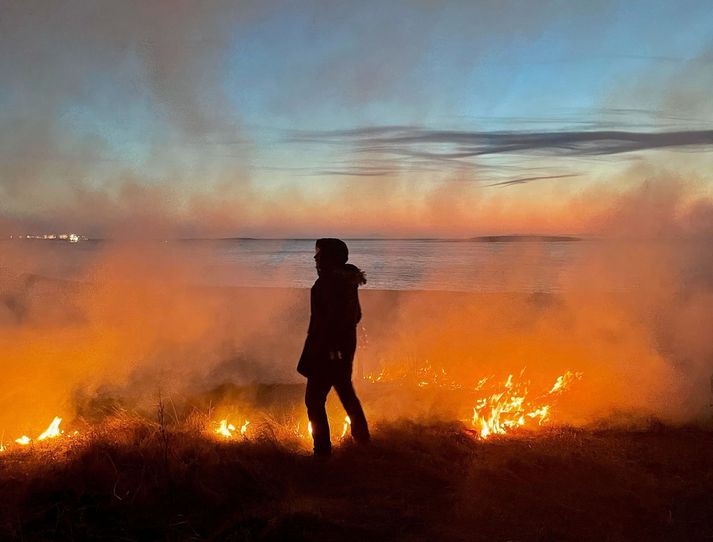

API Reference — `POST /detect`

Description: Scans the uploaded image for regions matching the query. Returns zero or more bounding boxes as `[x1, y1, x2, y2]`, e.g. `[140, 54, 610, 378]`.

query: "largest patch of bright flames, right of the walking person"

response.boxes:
[472, 370, 582, 439]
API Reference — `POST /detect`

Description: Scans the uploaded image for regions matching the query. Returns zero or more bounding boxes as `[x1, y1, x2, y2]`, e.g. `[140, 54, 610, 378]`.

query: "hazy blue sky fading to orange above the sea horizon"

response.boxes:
[0, 0, 713, 237]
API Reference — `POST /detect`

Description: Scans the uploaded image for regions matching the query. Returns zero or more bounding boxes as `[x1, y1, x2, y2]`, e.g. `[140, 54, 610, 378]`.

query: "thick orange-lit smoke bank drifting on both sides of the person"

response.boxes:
[0, 180, 713, 440]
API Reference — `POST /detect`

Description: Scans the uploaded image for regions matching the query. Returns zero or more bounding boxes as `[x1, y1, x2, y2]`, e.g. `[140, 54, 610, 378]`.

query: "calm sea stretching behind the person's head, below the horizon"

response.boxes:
[0, 239, 591, 292]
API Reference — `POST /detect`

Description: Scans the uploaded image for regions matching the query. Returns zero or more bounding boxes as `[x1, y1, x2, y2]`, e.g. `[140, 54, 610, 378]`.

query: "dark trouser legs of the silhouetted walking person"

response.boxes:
[305, 373, 369, 455]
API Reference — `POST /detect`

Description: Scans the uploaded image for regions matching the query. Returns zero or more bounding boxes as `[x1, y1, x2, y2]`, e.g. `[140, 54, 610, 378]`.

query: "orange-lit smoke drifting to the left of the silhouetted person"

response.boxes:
[0, 242, 306, 434]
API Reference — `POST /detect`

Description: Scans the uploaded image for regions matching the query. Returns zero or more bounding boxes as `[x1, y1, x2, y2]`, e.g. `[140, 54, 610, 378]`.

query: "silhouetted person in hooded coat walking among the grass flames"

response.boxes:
[297, 239, 369, 455]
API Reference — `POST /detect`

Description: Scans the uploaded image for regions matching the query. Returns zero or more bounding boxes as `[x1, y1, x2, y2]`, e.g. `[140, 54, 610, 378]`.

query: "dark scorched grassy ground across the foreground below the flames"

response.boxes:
[0, 421, 713, 541]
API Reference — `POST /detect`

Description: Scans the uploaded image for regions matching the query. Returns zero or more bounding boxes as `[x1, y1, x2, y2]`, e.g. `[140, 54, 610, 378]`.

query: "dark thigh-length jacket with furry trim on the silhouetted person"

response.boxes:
[297, 264, 366, 377]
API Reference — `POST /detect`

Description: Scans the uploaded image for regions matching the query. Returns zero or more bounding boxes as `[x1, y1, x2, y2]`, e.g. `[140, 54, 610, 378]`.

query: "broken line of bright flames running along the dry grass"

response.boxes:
[0, 367, 583, 453]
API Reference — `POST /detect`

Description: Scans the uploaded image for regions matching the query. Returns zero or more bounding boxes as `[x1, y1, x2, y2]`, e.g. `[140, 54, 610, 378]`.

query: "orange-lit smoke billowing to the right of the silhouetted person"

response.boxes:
[356, 178, 713, 424]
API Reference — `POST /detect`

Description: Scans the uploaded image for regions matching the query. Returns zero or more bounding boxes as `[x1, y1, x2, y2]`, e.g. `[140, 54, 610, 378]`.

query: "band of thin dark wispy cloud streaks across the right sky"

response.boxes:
[286, 126, 713, 186]
